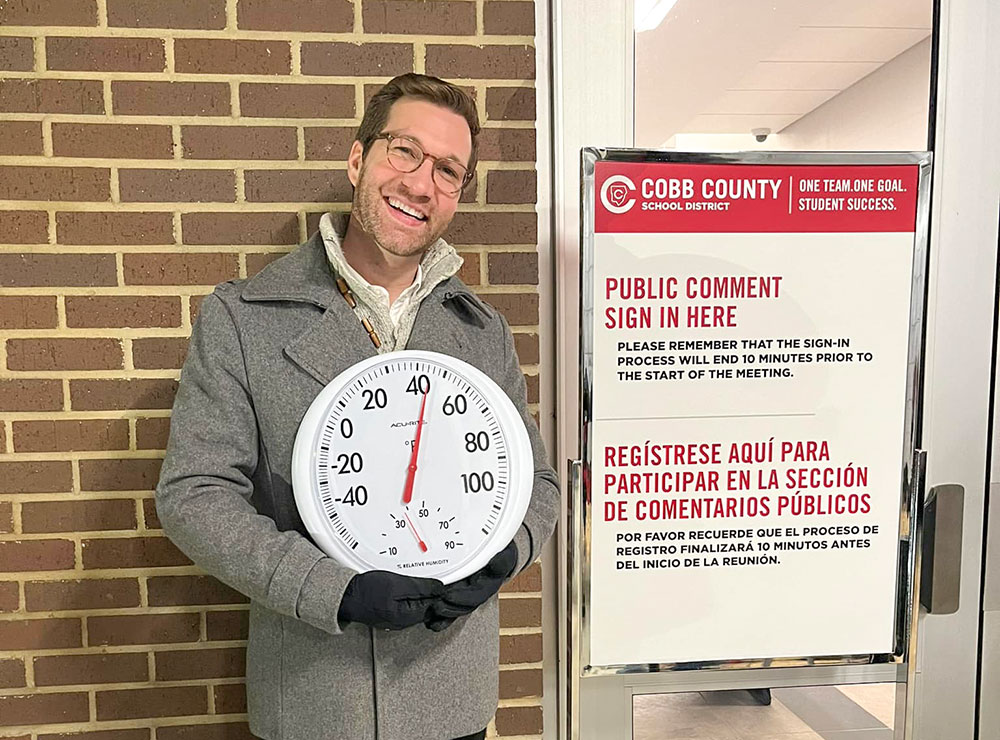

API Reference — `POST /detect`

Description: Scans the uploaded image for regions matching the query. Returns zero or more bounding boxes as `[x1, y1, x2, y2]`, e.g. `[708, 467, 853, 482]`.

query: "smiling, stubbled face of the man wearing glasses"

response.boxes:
[347, 98, 472, 257]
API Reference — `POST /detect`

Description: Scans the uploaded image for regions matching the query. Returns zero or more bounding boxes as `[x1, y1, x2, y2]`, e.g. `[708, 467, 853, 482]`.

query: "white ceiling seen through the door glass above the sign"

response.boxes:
[635, 0, 931, 146]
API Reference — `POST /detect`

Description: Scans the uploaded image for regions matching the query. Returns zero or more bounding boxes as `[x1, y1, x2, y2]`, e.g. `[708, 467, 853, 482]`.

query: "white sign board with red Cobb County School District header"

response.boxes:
[585, 155, 920, 666]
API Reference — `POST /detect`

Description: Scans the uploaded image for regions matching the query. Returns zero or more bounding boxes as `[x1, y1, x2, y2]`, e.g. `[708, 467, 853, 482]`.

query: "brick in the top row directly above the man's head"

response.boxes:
[361, 0, 476, 36]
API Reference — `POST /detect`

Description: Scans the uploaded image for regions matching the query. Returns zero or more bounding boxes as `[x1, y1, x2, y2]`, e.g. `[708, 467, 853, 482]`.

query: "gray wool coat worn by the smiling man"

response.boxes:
[156, 235, 559, 740]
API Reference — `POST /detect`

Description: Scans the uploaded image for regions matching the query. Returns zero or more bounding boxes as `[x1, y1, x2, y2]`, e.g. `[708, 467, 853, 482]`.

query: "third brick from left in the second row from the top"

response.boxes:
[174, 39, 292, 75]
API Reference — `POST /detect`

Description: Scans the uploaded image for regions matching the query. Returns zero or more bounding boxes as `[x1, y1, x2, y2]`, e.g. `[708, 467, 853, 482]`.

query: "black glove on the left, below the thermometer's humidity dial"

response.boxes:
[337, 570, 444, 630]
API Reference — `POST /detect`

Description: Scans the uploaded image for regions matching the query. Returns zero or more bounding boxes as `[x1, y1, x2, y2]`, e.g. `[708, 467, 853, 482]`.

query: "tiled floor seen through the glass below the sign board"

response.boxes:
[632, 684, 895, 740]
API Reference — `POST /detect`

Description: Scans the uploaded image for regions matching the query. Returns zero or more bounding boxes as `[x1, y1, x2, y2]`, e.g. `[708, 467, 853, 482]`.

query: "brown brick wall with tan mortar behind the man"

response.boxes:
[0, 0, 542, 740]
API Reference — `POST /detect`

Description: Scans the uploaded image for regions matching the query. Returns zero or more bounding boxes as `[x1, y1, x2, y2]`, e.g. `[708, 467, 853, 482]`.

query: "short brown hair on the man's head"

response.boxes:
[354, 72, 479, 172]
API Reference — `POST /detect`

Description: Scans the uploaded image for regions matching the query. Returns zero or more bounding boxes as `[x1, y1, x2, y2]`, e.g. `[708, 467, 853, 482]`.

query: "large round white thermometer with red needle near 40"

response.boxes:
[292, 350, 534, 583]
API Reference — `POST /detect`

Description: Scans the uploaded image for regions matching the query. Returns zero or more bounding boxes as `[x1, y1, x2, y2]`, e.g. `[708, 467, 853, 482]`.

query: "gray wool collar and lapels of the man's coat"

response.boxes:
[240, 233, 493, 385]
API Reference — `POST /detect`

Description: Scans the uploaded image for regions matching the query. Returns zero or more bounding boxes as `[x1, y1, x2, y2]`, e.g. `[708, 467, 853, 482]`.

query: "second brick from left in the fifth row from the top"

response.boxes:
[118, 169, 236, 203]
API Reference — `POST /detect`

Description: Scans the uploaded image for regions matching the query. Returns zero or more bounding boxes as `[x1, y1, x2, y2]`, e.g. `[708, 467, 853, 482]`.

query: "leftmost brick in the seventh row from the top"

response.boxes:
[0, 252, 118, 288]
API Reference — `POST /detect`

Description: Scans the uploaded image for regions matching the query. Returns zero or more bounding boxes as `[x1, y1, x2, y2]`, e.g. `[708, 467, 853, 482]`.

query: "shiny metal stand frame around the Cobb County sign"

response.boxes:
[567, 148, 931, 738]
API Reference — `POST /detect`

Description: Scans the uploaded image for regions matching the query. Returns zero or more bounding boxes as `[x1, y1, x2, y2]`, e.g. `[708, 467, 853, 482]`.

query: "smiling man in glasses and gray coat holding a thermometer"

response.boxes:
[157, 74, 558, 740]
